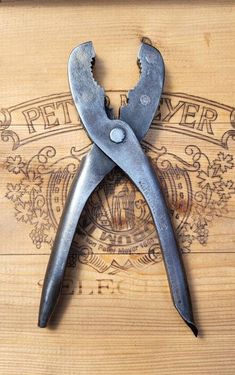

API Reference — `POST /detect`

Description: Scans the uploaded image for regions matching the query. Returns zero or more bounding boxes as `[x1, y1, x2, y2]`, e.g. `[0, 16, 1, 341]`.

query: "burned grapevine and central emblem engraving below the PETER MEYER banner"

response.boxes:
[5, 144, 235, 273]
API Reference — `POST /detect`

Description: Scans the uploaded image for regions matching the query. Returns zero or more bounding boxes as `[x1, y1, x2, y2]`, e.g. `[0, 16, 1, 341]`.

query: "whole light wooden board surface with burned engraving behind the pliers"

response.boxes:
[0, 0, 235, 375]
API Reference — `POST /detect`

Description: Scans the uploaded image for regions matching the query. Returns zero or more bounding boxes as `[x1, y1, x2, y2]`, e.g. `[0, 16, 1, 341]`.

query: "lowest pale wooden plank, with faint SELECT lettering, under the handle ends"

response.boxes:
[0, 254, 235, 375]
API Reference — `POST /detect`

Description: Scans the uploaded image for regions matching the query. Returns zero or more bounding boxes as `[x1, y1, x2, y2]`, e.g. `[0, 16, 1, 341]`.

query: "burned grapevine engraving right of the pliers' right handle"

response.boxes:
[179, 146, 235, 251]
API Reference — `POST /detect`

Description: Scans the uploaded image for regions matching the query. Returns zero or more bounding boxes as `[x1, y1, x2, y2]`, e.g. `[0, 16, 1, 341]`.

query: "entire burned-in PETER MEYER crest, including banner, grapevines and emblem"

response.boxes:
[0, 93, 235, 274]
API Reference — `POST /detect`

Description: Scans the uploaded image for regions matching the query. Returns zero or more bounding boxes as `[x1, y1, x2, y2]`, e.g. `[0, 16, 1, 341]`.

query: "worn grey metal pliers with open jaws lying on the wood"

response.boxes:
[38, 42, 198, 336]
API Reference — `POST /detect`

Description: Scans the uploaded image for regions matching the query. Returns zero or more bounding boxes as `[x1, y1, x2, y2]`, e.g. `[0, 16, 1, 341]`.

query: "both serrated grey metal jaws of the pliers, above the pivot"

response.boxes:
[68, 42, 165, 139]
